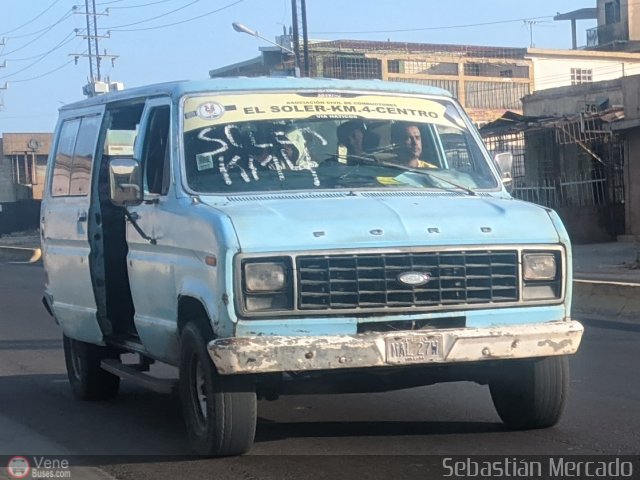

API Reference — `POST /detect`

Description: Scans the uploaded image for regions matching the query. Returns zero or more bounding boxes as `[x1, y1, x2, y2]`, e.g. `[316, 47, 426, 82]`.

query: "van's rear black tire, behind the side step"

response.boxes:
[62, 335, 120, 400]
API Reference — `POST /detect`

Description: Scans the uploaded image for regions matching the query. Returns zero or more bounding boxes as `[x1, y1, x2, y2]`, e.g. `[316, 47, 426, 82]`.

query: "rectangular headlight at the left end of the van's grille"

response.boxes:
[242, 258, 293, 313]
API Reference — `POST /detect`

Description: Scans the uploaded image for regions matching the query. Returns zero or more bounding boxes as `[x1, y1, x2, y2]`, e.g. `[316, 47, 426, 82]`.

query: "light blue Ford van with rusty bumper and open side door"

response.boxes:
[41, 78, 583, 455]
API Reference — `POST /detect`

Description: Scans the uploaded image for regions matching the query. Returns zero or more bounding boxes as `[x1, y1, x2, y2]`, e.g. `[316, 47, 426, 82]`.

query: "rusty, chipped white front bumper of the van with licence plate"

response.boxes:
[208, 320, 584, 375]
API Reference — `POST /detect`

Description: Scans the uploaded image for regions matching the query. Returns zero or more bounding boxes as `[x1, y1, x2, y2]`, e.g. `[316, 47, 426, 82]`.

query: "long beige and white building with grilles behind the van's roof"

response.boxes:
[209, 40, 640, 126]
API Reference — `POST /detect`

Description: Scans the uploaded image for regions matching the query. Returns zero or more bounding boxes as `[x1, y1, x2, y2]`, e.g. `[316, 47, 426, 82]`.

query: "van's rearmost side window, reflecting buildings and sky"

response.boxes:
[51, 115, 101, 197]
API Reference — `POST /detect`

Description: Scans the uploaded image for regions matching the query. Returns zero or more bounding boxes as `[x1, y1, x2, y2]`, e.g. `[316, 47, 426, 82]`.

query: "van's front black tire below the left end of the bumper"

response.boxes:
[179, 322, 257, 456]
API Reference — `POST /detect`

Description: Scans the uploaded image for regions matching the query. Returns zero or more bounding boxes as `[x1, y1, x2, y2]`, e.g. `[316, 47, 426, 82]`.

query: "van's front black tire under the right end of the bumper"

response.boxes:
[489, 356, 569, 430]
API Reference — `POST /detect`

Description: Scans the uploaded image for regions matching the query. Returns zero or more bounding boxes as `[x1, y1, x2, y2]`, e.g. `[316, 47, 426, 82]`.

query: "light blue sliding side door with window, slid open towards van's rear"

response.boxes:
[41, 112, 105, 343]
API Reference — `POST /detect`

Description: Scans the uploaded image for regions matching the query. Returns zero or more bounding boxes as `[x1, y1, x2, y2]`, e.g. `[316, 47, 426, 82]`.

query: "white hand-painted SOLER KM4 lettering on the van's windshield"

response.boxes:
[196, 124, 327, 187]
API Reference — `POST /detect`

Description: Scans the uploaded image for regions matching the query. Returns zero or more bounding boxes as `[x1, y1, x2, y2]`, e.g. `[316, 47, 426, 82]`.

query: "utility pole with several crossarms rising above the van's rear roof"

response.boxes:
[70, 0, 122, 97]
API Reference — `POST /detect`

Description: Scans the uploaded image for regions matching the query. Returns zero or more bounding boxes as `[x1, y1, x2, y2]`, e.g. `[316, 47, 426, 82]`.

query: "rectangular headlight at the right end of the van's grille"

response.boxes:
[522, 252, 563, 300]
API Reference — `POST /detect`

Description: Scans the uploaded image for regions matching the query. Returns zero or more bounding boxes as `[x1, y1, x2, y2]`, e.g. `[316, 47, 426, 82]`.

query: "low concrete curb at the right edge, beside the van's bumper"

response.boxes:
[571, 279, 640, 325]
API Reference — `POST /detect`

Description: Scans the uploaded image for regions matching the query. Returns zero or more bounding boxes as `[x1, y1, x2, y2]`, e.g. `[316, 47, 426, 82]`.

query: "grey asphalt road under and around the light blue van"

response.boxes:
[0, 264, 640, 480]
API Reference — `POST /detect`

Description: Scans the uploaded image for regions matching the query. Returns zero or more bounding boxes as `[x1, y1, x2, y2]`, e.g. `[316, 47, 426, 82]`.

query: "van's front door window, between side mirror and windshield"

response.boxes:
[142, 106, 170, 195]
